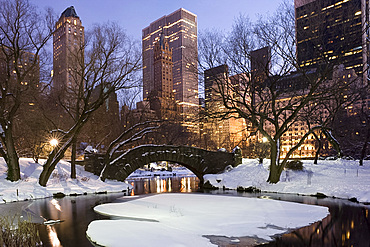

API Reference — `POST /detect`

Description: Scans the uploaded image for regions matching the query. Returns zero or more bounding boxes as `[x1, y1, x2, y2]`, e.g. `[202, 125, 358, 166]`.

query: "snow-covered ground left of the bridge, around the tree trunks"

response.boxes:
[0, 158, 131, 203]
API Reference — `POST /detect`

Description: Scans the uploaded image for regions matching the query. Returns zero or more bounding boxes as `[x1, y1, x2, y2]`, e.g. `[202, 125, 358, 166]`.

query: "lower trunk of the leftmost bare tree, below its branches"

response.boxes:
[4, 127, 21, 182]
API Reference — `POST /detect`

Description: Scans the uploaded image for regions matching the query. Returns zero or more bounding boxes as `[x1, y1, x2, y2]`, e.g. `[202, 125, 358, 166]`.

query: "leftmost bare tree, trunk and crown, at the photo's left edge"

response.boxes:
[0, 0, 54, 181]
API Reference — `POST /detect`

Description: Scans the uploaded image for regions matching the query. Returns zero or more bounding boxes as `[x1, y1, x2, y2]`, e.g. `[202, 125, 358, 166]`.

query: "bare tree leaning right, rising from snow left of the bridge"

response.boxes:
[39, 23, 140, 186]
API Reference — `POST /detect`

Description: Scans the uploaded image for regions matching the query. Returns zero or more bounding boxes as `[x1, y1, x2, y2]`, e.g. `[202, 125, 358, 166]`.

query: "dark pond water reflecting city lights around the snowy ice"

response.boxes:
[0, 177, 370, 247]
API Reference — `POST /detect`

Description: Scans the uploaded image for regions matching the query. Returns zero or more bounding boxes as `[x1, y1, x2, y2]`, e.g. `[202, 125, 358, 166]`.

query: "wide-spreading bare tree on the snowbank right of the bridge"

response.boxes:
[199, 4, 364, 183]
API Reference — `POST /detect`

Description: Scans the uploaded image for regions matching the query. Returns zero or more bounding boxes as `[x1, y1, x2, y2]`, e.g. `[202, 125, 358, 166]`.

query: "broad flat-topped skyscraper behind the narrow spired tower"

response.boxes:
[142, 8, 199, 123]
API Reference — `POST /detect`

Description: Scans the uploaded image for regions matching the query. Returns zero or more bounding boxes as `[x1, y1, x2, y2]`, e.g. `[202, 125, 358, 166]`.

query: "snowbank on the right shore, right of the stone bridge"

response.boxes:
[205, 159, 370, 203]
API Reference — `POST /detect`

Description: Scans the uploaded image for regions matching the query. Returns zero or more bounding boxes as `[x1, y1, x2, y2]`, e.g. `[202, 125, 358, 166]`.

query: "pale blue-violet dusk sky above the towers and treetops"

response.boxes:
[30, 0, 284, 40]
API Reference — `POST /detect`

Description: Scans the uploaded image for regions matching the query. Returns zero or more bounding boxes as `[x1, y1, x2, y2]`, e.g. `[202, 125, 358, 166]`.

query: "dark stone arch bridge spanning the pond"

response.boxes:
[85, 145, 242, 184]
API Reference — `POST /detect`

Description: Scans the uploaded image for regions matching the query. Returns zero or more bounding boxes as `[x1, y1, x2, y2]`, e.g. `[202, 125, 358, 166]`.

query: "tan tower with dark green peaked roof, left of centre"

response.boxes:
[53, 6, 84, 94]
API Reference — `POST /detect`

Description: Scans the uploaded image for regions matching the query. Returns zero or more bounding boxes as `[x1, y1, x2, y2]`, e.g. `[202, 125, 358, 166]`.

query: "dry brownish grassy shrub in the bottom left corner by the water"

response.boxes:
[0, 215, 42, 247]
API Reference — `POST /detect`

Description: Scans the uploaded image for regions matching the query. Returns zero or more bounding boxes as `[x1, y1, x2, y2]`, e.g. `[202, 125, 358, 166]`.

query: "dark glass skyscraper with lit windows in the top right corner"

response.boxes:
[294, 0, 369, 78]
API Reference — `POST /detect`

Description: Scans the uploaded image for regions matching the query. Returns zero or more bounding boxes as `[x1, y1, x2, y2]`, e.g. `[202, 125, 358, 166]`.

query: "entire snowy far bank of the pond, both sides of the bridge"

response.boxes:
[0, 158, 370, 203]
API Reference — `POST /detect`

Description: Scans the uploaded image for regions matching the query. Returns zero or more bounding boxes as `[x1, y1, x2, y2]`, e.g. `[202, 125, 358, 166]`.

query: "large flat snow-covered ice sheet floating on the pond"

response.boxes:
[87, 194, 329, 246]
